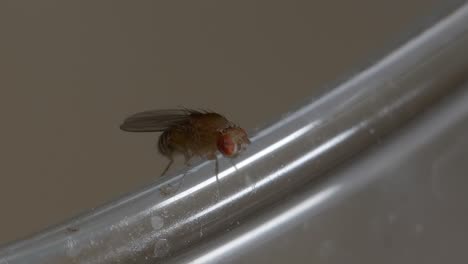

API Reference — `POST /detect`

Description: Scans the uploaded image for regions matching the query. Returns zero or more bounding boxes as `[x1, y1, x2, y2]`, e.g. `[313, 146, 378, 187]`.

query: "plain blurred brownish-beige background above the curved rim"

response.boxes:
[0, 0, 460, 244]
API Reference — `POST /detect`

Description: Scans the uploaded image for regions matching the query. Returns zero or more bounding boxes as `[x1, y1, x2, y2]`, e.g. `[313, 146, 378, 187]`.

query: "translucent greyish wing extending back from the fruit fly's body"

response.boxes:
[120, 109, 197, 132]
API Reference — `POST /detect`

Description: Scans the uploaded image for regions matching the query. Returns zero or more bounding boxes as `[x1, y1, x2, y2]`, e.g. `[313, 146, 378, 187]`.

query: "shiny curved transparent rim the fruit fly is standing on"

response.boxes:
[0, 2, 468, 264]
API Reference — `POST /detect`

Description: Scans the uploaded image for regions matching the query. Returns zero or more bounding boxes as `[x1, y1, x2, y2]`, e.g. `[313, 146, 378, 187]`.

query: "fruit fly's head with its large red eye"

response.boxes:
[217, 126, 250, 157]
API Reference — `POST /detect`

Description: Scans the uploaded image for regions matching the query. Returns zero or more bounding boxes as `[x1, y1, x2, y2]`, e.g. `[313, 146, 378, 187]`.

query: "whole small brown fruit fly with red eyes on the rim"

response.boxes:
[120, 109, 250, 192]
